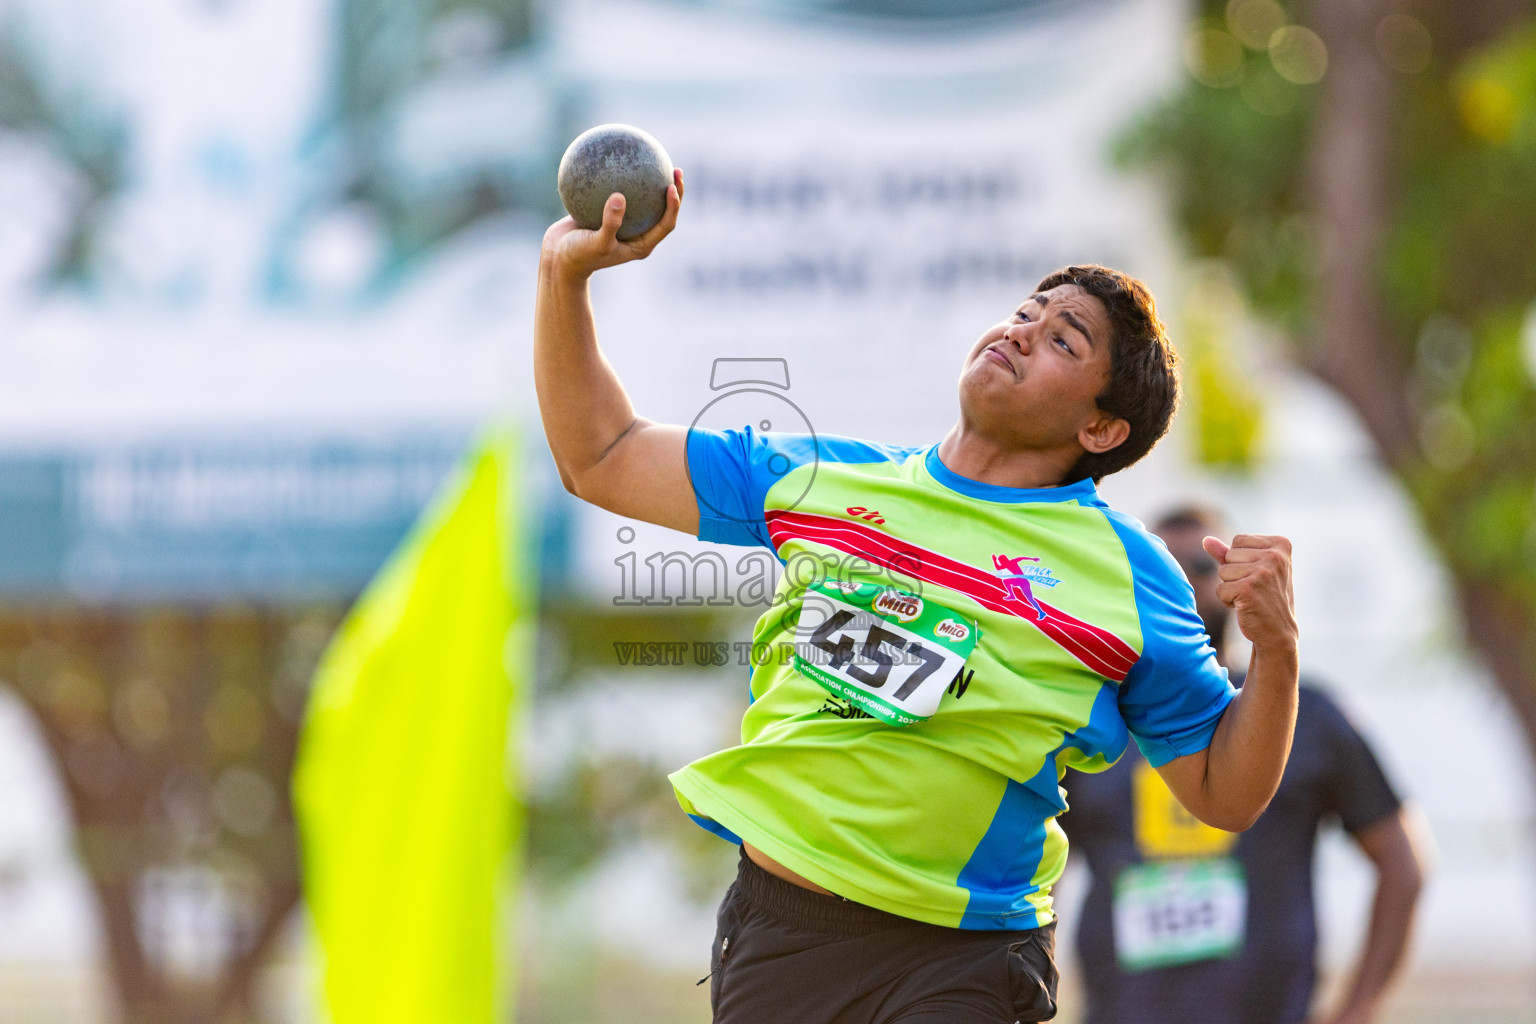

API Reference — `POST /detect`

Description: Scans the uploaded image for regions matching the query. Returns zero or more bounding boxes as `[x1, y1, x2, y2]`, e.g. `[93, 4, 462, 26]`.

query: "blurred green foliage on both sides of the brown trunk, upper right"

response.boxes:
[1118, 0, 1536, 607]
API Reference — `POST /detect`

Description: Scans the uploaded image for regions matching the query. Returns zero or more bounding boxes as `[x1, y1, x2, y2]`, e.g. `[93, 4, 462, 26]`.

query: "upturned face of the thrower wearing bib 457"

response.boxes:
[960, 284, 1130, 454]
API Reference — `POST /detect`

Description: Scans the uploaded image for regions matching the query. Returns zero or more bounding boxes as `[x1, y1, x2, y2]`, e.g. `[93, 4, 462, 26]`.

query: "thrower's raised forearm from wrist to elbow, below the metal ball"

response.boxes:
[533, 252, 636, 494]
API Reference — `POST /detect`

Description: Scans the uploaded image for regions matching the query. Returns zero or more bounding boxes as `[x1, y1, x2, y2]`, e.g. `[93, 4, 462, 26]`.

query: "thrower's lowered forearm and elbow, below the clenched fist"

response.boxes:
[1189, 643, 1298, 832]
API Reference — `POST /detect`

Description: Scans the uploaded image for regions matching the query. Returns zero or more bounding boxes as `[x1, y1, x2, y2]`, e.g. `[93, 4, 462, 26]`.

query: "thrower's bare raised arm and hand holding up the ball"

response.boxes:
[533, 170, 699, 533]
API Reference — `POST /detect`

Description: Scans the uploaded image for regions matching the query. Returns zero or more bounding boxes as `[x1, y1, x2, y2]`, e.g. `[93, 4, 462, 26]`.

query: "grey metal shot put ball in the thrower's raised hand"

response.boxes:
[556, 124, 671, 239]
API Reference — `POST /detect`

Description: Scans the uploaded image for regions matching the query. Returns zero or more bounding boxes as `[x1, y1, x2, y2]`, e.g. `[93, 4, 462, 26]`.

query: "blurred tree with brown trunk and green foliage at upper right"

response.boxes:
[1121, 0, 1536, 798]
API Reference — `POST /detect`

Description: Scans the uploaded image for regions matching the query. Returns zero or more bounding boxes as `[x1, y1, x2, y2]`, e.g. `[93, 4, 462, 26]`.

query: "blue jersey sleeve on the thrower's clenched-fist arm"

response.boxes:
[1106, 510, 1236, 768]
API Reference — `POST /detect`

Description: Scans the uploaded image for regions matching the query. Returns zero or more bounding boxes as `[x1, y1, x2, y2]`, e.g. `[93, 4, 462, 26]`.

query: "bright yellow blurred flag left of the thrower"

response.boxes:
[293, 436, 527, 1024]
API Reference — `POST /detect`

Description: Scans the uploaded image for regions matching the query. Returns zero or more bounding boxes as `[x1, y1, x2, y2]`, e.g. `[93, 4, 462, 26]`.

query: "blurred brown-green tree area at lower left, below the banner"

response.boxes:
[0, 608, 338, 1024]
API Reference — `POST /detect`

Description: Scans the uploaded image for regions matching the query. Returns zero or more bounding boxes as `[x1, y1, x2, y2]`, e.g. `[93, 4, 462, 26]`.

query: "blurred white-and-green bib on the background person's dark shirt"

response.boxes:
[1115, 858, 1247, 970]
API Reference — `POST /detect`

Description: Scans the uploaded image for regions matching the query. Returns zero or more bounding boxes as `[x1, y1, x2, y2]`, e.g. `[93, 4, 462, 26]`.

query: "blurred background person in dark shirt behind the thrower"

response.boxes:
[1061, 507, 1427, 1024]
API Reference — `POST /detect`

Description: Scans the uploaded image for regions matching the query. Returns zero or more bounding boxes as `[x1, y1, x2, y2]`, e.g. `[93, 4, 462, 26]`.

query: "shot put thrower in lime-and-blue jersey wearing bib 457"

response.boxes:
[533, 172, 1296, 1024]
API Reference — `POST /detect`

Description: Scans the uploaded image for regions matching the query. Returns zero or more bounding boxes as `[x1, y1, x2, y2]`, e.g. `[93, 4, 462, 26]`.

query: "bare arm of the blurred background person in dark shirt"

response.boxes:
[1318, 809, 1428, 1024]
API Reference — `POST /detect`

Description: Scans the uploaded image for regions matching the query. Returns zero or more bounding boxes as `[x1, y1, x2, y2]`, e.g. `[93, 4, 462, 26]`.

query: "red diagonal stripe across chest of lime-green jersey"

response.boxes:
[765, 511, 1138, 683]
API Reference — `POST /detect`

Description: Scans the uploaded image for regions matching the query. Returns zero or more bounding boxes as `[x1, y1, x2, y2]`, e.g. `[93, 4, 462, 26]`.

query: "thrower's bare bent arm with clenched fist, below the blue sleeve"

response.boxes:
[1158, 534, 1298, 832]
